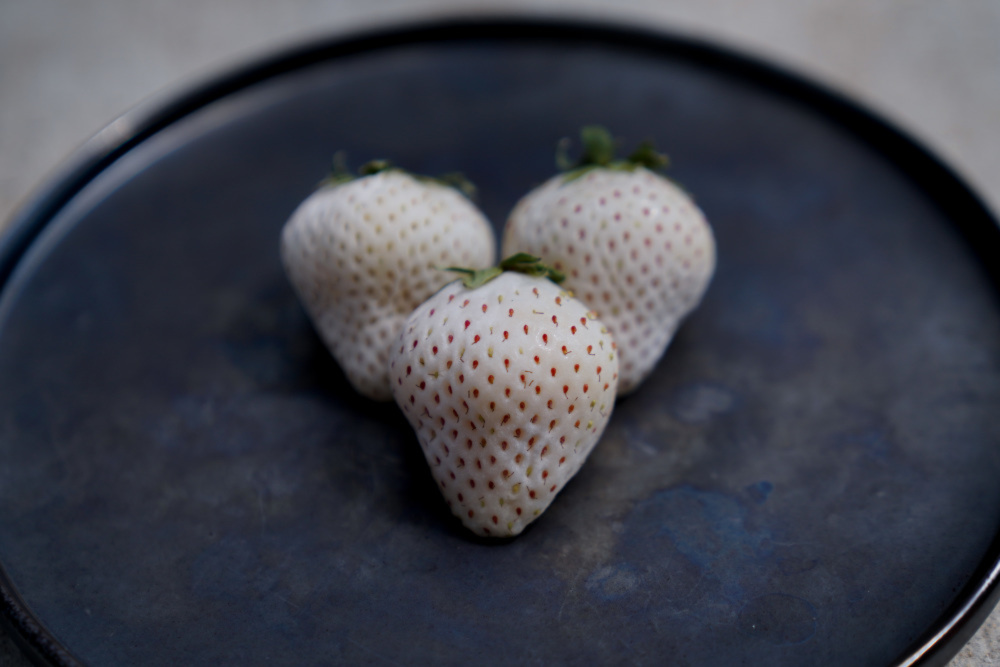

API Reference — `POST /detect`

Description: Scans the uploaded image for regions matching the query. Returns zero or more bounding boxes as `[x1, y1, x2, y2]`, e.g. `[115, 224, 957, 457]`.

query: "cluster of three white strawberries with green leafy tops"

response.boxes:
[281, 127, 715, 537]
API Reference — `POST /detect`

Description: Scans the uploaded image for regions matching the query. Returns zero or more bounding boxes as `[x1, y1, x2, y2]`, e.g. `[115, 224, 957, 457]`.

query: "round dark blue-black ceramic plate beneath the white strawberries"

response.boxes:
[0, 21, 1000, 667]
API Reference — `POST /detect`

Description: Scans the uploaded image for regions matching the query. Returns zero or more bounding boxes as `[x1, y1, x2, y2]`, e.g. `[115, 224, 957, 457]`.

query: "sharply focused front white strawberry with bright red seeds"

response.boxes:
[390, 256, 618, 537]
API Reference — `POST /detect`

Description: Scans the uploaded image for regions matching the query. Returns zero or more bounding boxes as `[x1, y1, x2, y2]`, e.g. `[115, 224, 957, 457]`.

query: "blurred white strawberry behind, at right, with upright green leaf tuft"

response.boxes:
[501, 127, 715, 395]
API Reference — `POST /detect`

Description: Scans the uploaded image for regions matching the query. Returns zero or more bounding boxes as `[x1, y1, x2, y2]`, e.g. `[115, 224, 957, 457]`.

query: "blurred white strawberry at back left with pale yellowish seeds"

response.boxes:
[281, 163, 496, 401]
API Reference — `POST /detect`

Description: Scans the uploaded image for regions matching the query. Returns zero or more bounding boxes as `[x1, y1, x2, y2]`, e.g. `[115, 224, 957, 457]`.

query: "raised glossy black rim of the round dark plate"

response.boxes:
[0, 13, 1000, 667]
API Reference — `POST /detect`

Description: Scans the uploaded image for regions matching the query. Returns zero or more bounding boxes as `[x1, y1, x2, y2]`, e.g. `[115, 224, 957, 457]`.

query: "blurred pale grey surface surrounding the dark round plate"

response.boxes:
[0, 0, 1000, 667]
